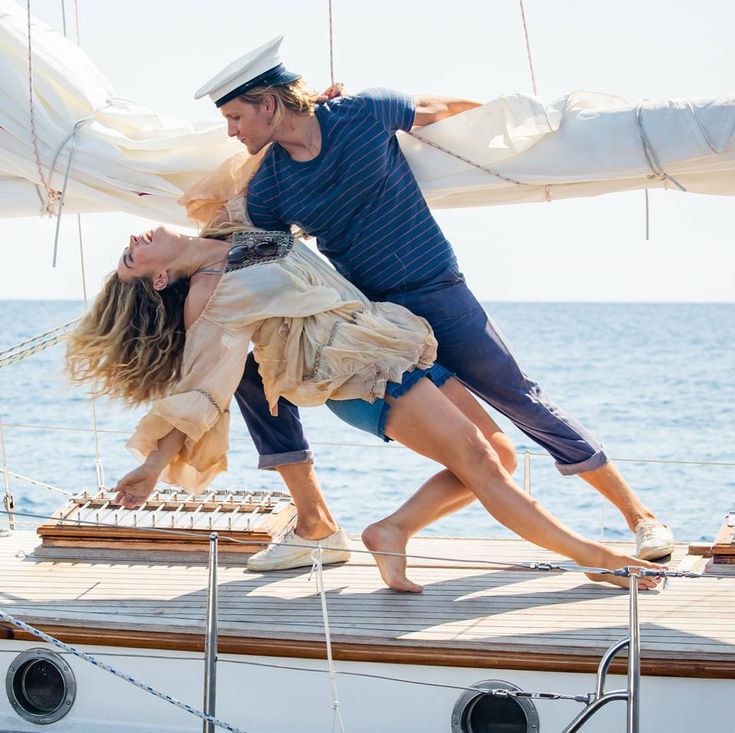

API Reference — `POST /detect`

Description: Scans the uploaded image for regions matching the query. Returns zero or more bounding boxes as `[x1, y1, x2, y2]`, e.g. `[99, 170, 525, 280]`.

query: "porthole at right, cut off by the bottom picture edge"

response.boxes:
[452, 680, 539, 733]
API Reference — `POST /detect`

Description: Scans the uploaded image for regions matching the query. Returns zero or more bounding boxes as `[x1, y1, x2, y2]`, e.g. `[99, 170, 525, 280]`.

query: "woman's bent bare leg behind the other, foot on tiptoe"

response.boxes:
[362, 378, 516, 593]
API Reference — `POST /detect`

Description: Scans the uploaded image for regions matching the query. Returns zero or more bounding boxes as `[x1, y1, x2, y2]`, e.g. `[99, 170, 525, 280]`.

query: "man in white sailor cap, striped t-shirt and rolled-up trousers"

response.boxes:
[196, 38, 673, 570]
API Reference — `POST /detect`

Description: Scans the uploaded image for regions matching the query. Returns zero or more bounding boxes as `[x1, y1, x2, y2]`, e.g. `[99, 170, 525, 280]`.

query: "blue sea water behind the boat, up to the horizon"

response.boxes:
[0, 301, 735, 541]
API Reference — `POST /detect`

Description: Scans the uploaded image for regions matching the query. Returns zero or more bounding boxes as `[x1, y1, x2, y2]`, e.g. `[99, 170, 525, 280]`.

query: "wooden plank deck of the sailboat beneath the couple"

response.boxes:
[0, 532, 735, 678]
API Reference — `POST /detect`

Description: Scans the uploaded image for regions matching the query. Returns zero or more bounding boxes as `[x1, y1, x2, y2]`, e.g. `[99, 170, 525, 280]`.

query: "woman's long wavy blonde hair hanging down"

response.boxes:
[66, 223, 253, 407]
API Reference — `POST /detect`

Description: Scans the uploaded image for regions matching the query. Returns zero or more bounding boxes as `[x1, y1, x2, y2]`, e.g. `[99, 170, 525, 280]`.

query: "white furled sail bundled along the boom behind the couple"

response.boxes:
[0, 0, 735, 224]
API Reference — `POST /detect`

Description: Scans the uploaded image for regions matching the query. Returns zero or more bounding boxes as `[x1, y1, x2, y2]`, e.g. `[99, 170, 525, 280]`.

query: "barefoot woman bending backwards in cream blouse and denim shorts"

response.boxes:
[67, 220, 658, 592]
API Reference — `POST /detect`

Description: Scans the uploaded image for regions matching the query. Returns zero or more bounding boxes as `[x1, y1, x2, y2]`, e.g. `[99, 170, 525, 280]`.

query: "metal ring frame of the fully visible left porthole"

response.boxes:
[5, 647, 77, 725]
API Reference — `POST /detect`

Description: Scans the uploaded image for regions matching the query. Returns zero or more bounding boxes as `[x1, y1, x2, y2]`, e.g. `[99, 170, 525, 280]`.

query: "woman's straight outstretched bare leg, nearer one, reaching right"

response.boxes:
[368, 379, 660, 589]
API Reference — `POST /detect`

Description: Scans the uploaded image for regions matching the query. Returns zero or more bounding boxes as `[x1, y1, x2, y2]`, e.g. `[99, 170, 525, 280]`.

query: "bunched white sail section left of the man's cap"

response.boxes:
[0, 0, 239, 224]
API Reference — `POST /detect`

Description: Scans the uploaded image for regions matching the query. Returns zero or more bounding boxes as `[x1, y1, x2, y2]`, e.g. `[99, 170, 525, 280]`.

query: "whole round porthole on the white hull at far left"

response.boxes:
[5, 648, 77, 725]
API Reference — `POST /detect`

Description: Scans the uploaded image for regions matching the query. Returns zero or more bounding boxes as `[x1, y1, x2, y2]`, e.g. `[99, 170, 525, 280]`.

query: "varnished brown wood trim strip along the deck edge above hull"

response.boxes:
[0, 623, 735, 679]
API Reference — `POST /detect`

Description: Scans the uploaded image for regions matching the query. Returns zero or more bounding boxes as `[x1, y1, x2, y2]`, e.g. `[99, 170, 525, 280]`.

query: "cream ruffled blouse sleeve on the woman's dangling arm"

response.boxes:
[127, 319, 253, 494]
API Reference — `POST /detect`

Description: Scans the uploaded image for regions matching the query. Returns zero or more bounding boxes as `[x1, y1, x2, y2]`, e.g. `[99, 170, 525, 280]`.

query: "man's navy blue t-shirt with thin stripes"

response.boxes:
[247, 89, 457, 300]
